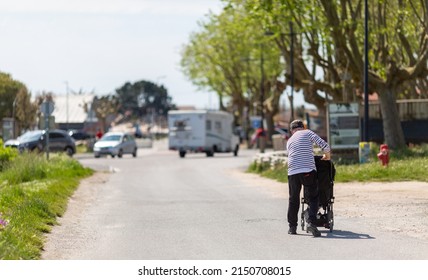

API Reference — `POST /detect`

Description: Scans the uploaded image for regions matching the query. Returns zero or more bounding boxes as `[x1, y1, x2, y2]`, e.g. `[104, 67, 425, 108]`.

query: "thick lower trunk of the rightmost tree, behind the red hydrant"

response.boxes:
[379, 88, 406, 149]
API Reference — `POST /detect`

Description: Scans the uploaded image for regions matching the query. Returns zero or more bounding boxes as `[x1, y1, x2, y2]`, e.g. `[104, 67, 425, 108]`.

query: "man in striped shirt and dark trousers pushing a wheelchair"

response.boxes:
[287, 120, 330, 237]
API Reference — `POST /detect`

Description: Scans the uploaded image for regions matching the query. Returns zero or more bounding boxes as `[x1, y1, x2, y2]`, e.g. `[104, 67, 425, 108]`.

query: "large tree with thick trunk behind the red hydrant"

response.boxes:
[320, 0, 428, 148]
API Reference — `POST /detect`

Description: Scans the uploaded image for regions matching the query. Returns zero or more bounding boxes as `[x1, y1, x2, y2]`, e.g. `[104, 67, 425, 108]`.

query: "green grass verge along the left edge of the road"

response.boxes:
[0, 153, 93, 260]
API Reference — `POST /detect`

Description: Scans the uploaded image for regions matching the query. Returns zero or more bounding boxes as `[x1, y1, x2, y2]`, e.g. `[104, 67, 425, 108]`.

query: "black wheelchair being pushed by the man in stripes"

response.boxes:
[301, 156, 336, 232]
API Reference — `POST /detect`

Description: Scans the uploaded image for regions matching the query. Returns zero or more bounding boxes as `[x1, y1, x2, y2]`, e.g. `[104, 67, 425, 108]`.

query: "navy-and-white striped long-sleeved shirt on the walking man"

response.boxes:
[287, 129, 330, 175]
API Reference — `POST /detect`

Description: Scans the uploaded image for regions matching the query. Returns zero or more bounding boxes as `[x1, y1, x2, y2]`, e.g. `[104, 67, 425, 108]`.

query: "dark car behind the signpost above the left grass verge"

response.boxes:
[18, 129, 76, 156]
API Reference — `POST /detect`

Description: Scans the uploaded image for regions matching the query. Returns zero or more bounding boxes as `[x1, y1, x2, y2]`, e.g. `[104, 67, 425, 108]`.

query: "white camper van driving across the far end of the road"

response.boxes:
[168, 110, 239, 158]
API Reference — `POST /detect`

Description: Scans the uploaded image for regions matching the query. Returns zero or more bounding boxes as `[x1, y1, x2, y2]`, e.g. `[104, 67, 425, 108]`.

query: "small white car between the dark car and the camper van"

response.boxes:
[94, 132, 138, 158]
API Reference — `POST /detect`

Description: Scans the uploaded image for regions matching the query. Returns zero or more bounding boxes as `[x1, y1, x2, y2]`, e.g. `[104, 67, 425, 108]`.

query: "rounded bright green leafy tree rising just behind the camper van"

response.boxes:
[181, 4, 283, 138]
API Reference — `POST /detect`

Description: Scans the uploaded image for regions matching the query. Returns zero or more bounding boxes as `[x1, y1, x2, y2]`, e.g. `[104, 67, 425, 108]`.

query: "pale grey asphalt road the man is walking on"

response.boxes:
[43, 142, 428, 260]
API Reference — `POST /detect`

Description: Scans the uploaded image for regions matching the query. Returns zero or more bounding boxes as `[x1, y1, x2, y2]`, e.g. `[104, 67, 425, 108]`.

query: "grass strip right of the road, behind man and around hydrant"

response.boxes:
[247, 145, 428, 182]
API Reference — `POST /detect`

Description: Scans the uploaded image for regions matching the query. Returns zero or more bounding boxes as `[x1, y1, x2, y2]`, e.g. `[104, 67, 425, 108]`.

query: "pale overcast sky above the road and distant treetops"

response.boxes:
[0, 0, 222, 108]
